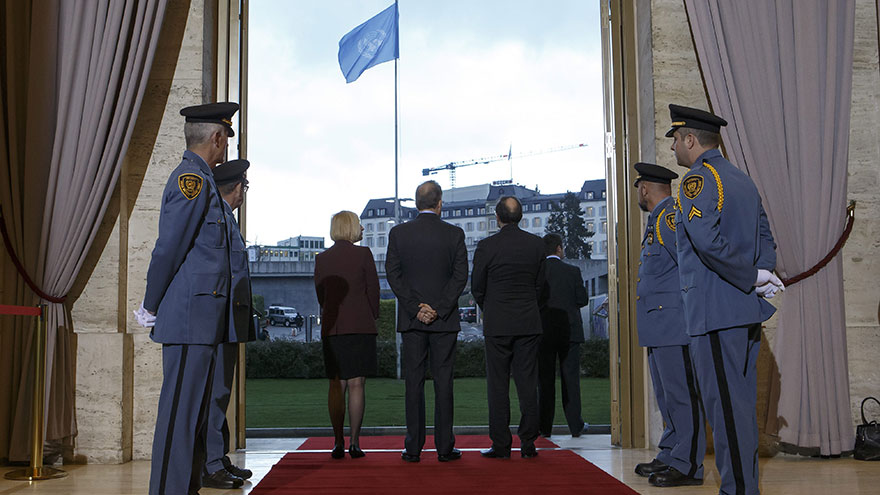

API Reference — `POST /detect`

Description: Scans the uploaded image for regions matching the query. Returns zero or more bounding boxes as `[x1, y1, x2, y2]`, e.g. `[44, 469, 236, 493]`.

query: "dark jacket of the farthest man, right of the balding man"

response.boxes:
[541, 258, 589, 342]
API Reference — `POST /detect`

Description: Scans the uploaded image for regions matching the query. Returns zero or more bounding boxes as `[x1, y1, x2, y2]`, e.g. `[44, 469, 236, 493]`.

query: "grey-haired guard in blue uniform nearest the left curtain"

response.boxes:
[143, 103, 242, 495]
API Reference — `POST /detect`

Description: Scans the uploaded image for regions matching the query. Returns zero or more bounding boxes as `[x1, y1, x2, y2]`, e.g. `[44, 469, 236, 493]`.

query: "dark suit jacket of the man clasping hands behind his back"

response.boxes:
[385, 213, 467, 332]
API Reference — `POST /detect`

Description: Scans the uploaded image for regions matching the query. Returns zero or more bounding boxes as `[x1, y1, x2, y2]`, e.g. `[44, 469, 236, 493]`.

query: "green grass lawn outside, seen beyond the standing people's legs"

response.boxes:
[247, 378, 611, 428]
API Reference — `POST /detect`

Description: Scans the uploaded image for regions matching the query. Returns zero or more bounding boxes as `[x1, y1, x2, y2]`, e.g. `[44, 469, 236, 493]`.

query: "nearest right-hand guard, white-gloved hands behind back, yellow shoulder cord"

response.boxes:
[666, 105, 784, 495]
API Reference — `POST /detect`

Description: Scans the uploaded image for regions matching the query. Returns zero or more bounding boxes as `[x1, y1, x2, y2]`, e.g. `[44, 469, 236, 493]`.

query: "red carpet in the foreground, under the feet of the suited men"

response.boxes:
[250, 435, 638, 495]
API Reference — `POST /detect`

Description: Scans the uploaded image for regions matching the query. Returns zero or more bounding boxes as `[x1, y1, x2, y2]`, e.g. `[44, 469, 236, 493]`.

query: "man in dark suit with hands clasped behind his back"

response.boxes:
[385, 181, 468, 462]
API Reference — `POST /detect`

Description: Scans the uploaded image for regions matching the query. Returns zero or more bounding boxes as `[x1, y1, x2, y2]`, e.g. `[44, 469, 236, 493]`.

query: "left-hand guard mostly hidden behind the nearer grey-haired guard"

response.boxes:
[202, 160, 256, 489]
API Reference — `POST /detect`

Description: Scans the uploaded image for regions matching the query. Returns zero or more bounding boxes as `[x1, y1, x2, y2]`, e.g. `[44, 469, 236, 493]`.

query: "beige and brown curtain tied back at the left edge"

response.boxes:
[0, 0, 166, 460]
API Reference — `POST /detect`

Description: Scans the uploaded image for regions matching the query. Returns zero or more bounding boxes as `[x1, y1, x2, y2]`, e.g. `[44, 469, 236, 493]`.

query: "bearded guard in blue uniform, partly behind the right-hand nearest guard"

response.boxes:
[635, 163, 706, 486]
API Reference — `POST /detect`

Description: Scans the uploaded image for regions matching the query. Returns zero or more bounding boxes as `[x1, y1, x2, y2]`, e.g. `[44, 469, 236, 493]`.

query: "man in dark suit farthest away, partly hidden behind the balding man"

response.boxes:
[538, 234, 589, 437]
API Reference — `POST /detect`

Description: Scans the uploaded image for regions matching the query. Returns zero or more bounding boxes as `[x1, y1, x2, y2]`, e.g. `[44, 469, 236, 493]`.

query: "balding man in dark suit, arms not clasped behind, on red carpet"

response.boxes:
[471, 196, 544, 459]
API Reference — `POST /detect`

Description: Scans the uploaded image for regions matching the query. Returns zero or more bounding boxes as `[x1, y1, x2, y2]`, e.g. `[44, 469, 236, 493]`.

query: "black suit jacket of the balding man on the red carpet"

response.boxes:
[471, 224, 544, 337]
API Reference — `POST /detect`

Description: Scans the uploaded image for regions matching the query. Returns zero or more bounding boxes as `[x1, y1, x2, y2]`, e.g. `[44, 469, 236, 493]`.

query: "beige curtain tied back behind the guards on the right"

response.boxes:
[685, 0, 855, 455]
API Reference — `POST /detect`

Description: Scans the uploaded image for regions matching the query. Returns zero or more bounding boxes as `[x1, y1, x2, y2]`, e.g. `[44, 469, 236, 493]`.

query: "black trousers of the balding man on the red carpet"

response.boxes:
[485, 335, 541, 454]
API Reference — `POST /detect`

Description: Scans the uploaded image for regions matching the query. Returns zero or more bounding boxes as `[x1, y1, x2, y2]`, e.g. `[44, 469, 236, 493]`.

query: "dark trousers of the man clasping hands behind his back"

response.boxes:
[401, 330, 458, 455]
